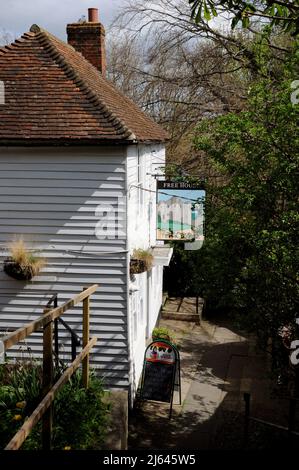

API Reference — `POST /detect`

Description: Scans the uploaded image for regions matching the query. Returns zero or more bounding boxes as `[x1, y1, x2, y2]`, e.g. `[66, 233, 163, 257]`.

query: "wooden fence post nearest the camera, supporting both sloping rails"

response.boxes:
[42, 308, 53, 450]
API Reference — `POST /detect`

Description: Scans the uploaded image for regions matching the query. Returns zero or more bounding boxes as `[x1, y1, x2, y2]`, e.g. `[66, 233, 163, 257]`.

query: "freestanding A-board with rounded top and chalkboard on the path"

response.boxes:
[141, 339, 181, 417]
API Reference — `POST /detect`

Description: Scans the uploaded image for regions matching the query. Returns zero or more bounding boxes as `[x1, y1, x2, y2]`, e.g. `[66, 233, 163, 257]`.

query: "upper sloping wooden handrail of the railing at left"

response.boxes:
[0, 284, 98, 351]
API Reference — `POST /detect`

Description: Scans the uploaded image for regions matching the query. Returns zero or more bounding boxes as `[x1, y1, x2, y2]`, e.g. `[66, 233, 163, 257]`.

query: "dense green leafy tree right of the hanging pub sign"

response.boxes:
[195, 39, 299, 364]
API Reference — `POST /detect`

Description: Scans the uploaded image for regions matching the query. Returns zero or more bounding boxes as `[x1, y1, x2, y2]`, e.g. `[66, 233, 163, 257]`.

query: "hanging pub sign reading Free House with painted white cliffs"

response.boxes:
[157, 180, 205, 242]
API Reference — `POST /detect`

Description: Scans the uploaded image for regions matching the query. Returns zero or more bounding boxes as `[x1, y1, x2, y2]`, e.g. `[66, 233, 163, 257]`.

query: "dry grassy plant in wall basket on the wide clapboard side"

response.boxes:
[4, 239, 46, 281]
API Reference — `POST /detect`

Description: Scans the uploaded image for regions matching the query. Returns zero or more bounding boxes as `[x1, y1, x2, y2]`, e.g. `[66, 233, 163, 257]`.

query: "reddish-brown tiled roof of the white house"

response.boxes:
[0, 25, 167, 144]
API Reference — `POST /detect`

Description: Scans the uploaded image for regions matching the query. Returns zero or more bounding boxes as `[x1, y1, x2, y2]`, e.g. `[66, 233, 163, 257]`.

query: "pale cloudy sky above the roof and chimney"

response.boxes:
[0, 0, 124, 39]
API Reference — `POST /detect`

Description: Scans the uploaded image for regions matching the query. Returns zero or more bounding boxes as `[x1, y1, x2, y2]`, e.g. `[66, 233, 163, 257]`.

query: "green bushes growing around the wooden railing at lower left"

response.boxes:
[0, 361, 110, 450]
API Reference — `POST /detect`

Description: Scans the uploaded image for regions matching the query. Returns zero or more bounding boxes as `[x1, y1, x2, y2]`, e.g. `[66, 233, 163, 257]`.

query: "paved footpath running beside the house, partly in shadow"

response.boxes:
[129, 320, 287, 450]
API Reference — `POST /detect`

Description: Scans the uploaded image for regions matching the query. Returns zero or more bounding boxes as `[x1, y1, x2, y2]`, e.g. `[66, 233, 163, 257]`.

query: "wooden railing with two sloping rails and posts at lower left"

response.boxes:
[1, 284, 98, 450]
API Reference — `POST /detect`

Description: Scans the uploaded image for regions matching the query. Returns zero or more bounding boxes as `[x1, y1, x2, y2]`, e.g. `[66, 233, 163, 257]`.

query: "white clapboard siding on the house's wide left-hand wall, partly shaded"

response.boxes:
[0, 146, 129, 387]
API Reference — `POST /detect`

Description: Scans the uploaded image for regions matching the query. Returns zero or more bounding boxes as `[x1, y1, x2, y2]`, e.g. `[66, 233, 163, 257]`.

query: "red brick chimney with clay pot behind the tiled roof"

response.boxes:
[66, 8, 106, 76]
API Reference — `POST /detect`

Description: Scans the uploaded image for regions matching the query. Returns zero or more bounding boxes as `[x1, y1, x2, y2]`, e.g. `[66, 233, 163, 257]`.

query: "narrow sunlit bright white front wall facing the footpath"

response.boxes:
[127, 145, 165, 394]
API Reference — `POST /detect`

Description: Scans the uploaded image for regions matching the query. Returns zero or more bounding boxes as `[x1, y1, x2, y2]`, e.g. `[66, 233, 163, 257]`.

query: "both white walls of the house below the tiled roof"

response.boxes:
[0, 145, 165, 396]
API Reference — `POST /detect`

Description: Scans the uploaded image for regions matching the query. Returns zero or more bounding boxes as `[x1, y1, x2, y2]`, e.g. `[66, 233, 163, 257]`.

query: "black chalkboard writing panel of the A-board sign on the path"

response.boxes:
[142, 362, 176, 403]
